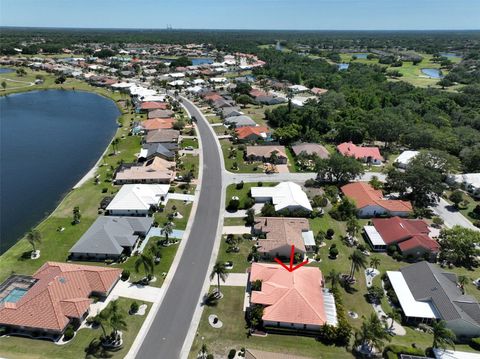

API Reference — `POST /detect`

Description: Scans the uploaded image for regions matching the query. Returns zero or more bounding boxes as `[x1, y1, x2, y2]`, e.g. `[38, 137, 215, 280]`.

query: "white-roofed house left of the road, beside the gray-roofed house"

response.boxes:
[106, 184, 170, 216]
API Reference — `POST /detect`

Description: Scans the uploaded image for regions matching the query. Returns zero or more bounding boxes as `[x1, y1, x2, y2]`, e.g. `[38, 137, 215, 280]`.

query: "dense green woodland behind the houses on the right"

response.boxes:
[257, 53, 480, 171]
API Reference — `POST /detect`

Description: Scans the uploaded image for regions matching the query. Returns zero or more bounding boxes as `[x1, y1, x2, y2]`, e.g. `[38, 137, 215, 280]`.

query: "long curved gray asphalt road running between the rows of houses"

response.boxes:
[136, 97, 222, 359]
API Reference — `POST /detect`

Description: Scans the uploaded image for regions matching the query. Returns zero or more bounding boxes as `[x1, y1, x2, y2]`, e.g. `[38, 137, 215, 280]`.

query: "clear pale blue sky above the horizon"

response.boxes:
[0, 0, 480, 30]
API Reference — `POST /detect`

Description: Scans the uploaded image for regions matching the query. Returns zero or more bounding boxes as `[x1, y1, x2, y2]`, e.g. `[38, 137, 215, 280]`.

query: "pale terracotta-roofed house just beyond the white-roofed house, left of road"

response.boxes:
[114, 157, 176, 184]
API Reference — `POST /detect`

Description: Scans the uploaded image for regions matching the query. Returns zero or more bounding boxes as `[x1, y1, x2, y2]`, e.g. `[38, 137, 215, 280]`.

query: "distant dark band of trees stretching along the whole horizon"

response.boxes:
[0, 27, 480, 54]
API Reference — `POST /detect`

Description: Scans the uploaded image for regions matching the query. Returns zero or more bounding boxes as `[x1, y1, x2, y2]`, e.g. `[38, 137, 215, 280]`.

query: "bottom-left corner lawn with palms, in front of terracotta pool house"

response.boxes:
[0, 298, 151, 359]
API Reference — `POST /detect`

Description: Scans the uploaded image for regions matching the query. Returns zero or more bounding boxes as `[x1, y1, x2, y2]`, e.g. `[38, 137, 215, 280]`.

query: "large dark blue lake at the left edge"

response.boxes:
[0, 90, 120, 253]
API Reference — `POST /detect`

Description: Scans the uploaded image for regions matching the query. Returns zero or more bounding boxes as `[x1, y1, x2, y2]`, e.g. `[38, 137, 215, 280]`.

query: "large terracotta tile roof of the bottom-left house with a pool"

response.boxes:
[0, 262, 122, 331]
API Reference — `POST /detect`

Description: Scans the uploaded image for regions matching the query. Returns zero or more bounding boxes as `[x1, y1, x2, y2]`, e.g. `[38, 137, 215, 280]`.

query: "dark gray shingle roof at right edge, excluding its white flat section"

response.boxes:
[400, 262, 480, 325]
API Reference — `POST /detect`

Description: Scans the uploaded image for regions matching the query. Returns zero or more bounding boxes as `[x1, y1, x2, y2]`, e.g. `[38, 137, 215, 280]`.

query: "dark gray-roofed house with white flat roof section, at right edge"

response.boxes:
[387, 261, 480, 338]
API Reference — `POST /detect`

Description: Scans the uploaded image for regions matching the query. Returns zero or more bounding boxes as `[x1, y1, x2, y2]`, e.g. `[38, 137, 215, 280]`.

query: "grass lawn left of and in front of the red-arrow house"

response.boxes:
[189, 286, 352, 359]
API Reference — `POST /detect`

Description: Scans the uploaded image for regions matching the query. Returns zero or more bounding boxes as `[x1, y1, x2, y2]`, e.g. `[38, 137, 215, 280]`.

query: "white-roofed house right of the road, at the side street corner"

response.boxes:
[250, 182, 312, 211]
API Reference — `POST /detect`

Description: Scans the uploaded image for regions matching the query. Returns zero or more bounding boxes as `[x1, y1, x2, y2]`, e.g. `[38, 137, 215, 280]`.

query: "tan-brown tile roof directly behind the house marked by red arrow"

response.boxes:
[254, 217, 310, 253]
